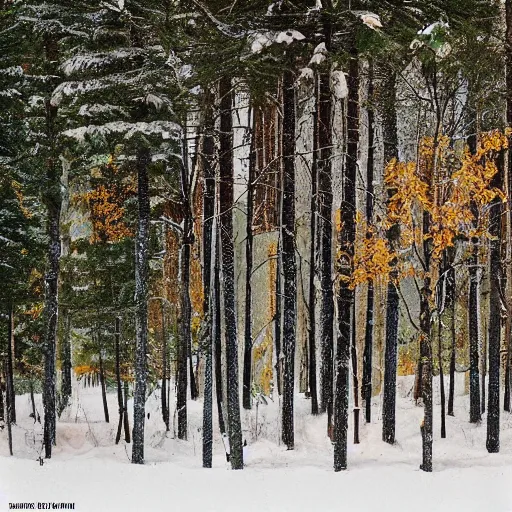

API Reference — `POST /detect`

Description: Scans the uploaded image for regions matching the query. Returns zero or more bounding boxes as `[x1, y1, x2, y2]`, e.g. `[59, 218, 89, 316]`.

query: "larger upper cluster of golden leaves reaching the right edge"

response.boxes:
[385, 130, 509, 259]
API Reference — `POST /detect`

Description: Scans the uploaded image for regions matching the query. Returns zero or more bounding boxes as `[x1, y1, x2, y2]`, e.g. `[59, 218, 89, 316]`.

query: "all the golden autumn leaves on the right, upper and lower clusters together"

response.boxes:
[344, 129, 512, 288]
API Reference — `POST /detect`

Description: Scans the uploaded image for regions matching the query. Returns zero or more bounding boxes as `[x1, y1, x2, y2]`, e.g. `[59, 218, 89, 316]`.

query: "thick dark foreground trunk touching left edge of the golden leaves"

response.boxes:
[333, 49, 359, 471]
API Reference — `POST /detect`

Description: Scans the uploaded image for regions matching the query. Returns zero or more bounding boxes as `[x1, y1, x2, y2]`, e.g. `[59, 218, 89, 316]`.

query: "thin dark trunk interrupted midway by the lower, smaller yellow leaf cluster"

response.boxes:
[362, 60, 375, 423]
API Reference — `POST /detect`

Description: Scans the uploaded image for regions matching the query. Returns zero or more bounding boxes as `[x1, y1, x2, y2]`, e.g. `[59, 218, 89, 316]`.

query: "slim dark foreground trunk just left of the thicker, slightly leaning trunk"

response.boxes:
[201, 91, 215, 468]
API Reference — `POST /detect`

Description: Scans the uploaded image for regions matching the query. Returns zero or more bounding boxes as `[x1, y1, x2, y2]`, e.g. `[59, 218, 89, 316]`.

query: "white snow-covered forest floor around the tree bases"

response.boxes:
[0, 376, 512, 512]
